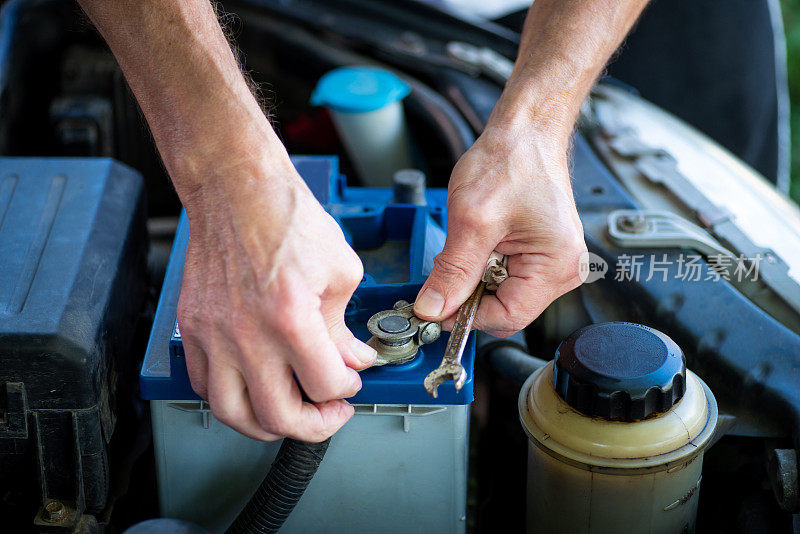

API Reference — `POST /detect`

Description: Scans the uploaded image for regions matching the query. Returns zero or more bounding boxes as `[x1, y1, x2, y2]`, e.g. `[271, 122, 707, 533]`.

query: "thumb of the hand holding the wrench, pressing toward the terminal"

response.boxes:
[414, 231, 496, 321]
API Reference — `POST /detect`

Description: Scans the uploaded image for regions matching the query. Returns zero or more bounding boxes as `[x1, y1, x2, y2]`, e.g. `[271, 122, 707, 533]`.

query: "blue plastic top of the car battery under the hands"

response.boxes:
[140, 156, 475, 404]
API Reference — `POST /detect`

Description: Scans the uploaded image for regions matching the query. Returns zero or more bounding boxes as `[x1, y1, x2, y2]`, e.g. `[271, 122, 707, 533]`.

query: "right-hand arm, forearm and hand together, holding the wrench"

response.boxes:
[414, 0, 647, 336]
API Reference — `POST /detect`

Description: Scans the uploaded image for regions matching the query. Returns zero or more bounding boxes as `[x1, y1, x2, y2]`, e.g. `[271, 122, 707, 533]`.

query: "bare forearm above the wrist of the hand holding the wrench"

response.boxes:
[489, 0, 647, 143]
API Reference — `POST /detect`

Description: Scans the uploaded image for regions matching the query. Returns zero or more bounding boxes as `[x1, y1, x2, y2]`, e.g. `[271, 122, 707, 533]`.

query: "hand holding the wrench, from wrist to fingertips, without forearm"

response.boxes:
[414, 128, 586, 337]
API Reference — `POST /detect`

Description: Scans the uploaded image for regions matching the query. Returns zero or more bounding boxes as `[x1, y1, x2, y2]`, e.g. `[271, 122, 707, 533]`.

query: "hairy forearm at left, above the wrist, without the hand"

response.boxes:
[79, 0, 285, 203]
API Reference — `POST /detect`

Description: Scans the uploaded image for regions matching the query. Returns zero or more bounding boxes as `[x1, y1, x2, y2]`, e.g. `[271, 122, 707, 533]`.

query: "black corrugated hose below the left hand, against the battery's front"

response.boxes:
[226, 438, 331, 534]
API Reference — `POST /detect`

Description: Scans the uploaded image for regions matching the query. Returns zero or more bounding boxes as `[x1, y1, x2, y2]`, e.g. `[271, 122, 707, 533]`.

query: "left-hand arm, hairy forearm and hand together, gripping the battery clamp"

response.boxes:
[76, 0, 382, 441]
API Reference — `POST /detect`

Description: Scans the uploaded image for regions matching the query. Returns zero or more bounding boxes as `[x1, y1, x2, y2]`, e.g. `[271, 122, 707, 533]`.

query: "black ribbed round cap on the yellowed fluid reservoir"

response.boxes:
[553, 323, 686, 421]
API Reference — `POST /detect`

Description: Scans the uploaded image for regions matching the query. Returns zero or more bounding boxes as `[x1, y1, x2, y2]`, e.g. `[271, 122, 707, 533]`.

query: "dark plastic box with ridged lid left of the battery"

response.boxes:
[0, 158, 147, 526]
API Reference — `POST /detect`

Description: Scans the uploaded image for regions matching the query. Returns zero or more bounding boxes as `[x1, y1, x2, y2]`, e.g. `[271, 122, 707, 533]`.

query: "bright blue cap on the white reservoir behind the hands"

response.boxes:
[311, 67, 411, 113]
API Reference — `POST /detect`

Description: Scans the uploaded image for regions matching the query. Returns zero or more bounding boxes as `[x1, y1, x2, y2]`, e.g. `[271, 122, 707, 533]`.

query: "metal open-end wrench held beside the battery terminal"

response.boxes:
[423, 253, 508, 399]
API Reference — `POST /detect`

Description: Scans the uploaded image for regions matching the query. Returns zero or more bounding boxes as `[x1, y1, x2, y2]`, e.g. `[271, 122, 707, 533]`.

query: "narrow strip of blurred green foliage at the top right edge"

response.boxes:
[781, 0, 800, 202]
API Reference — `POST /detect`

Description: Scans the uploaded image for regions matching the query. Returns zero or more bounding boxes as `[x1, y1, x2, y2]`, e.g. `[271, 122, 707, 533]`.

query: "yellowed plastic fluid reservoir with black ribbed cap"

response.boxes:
[519, 323, 717, 534]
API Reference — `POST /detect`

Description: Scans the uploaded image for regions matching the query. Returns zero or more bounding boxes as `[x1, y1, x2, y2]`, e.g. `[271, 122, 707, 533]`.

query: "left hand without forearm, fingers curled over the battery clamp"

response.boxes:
[178, 152, 375, 441]
